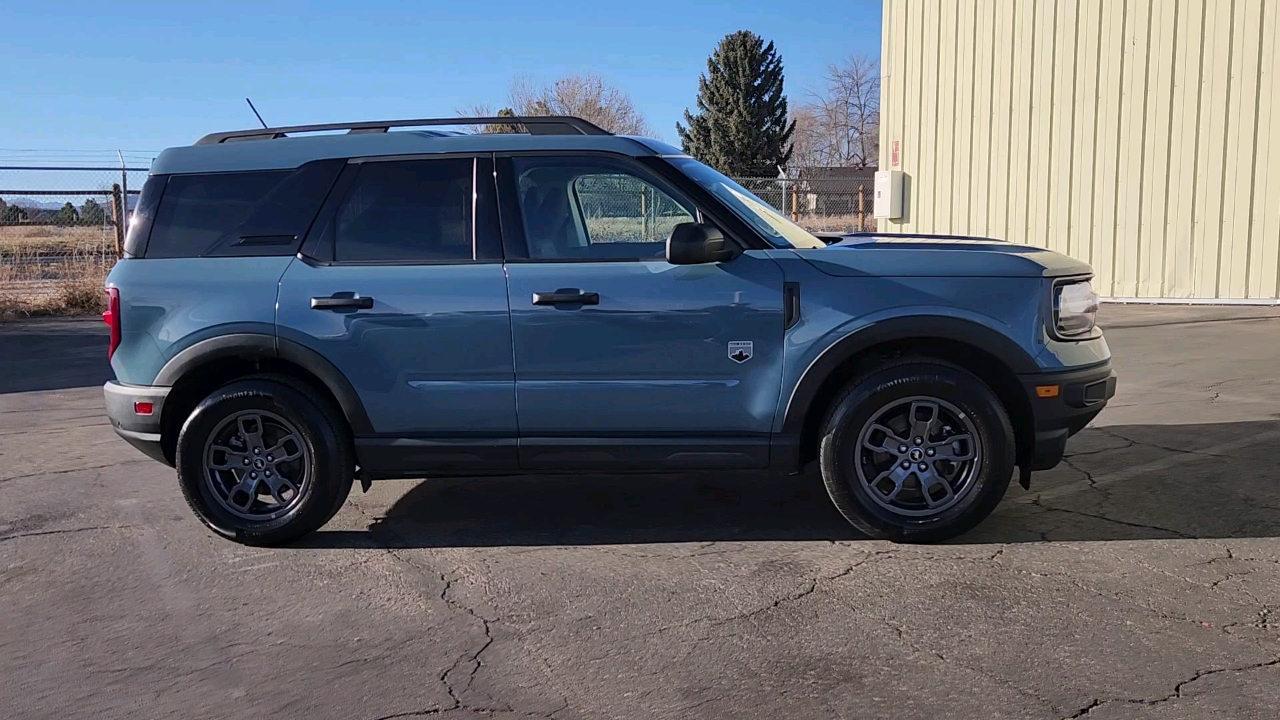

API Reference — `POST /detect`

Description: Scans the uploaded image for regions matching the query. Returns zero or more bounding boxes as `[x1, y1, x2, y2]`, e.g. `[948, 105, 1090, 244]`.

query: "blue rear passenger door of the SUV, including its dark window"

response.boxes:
[276, 156, 516, 475]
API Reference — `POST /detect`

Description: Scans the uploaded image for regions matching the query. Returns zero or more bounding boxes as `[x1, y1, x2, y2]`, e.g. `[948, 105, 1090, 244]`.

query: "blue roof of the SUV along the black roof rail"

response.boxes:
[151, 118, 678, 174]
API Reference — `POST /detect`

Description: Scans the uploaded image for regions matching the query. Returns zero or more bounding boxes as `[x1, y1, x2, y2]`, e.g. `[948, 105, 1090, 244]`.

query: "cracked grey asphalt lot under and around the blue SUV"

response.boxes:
[0, 306, 1280, 720]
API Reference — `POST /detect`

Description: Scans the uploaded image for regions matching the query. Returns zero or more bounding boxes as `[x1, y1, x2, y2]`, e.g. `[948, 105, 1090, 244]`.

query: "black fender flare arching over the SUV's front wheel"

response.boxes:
[782, 315, 1039, 437]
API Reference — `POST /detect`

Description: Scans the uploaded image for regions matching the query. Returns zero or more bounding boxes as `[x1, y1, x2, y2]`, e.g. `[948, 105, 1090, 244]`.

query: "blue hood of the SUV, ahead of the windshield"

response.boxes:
[796, 234, 1093, 278]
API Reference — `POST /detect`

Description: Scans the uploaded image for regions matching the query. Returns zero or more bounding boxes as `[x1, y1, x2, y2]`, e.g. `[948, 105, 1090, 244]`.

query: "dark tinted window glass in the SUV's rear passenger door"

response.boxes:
[334, 159, 474, 263]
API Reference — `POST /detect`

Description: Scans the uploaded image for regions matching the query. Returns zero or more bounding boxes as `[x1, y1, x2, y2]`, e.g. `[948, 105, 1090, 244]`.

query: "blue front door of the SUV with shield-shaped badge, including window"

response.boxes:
[499, 155, 783, 470]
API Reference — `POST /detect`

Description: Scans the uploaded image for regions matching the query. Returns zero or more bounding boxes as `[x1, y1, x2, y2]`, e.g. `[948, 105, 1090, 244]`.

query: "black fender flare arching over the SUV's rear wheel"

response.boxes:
[152, 333, 374, 436]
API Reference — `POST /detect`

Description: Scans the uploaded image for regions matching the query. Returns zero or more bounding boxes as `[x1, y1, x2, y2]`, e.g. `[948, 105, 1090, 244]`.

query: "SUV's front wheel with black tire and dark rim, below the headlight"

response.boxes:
[819, 359, 1015, 542]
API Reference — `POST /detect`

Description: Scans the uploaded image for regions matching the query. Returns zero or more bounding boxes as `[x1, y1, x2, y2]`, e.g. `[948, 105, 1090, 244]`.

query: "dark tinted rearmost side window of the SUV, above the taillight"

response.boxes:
[143, 170, 291, 258]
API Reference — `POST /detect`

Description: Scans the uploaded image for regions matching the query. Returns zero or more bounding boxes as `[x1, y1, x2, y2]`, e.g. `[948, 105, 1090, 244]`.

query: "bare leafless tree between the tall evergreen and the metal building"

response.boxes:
[791, 55, 879, 168]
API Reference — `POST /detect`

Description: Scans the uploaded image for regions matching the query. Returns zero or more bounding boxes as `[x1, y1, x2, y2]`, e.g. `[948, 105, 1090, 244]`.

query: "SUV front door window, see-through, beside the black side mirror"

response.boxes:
[516, 159, 694, 260]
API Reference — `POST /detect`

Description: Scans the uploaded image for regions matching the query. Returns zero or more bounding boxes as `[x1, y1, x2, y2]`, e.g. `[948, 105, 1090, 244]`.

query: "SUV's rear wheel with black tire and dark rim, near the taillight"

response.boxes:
[175, 377, 355, 544]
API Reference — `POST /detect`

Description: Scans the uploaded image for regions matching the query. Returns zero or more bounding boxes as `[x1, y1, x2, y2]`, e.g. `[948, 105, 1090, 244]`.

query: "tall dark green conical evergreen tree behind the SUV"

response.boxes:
[676, 29, 795, 178]
